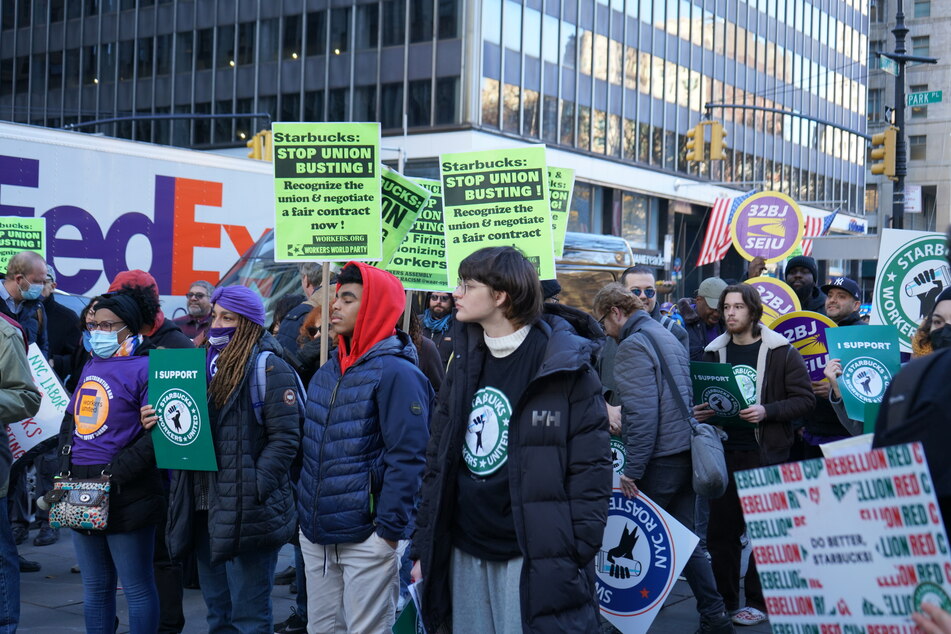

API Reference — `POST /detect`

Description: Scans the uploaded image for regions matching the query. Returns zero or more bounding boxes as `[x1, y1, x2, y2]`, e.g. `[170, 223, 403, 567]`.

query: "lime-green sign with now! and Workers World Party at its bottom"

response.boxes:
[273, 123, 383, 262]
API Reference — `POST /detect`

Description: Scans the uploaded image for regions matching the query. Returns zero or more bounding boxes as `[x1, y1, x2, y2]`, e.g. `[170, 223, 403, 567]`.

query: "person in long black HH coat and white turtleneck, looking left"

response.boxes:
[413, 247, 612, 632]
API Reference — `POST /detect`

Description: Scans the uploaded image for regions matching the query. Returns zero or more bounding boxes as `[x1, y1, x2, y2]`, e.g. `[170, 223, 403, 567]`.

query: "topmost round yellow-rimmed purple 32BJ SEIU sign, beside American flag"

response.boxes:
[730, 192, 804, 262]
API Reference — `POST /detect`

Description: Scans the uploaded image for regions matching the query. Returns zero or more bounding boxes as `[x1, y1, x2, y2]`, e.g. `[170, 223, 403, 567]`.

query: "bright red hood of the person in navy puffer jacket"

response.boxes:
[337, 262, 406, 374]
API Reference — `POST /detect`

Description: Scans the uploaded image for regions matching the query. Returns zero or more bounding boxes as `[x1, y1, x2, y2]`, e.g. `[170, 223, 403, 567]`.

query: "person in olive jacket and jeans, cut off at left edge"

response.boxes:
[0, 319, 40, 632]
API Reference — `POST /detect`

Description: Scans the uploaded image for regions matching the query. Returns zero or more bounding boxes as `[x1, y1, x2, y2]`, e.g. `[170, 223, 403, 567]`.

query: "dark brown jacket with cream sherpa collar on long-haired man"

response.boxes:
[703, 325, 816, 465]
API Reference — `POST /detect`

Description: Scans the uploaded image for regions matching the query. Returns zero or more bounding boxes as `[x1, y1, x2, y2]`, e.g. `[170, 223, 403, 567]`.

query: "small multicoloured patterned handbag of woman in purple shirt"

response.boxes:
[44, 474, 111, 531]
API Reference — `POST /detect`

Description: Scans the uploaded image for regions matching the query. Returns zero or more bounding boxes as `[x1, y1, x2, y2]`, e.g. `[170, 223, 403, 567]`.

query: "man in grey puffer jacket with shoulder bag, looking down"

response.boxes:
[594, 284, 734, 634]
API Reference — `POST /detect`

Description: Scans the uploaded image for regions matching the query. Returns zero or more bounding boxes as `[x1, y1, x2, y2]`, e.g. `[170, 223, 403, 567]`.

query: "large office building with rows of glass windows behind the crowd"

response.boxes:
[0, 0, 869, 290]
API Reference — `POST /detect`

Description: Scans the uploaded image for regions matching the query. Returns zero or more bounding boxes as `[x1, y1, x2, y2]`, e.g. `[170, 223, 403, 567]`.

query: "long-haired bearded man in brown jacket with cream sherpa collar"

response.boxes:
[694, 284, 816, 625]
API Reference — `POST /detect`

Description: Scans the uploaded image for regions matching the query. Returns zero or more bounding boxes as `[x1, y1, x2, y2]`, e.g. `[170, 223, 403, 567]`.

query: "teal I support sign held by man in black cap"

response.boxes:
[826, 326, 901, 429]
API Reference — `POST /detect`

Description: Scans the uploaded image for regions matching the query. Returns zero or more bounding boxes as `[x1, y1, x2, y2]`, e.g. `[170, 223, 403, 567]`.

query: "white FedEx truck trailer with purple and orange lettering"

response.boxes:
[0, 123, 274, 312]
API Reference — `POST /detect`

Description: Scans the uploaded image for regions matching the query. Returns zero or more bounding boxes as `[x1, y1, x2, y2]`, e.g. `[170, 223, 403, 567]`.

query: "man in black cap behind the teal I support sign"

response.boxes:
[802, 277, 865, 458]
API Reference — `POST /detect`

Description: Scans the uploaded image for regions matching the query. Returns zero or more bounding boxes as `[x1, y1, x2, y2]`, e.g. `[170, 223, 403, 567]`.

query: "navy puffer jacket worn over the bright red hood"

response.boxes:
[297, 331, 433, 545]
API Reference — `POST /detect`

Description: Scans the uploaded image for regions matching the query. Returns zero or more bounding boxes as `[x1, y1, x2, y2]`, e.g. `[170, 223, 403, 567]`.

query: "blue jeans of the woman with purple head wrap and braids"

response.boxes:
[195, 512, 278, 634]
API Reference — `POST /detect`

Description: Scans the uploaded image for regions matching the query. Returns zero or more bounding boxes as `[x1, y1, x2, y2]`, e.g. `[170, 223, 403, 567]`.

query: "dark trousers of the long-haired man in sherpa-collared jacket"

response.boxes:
[707, 450, 766, 612]
